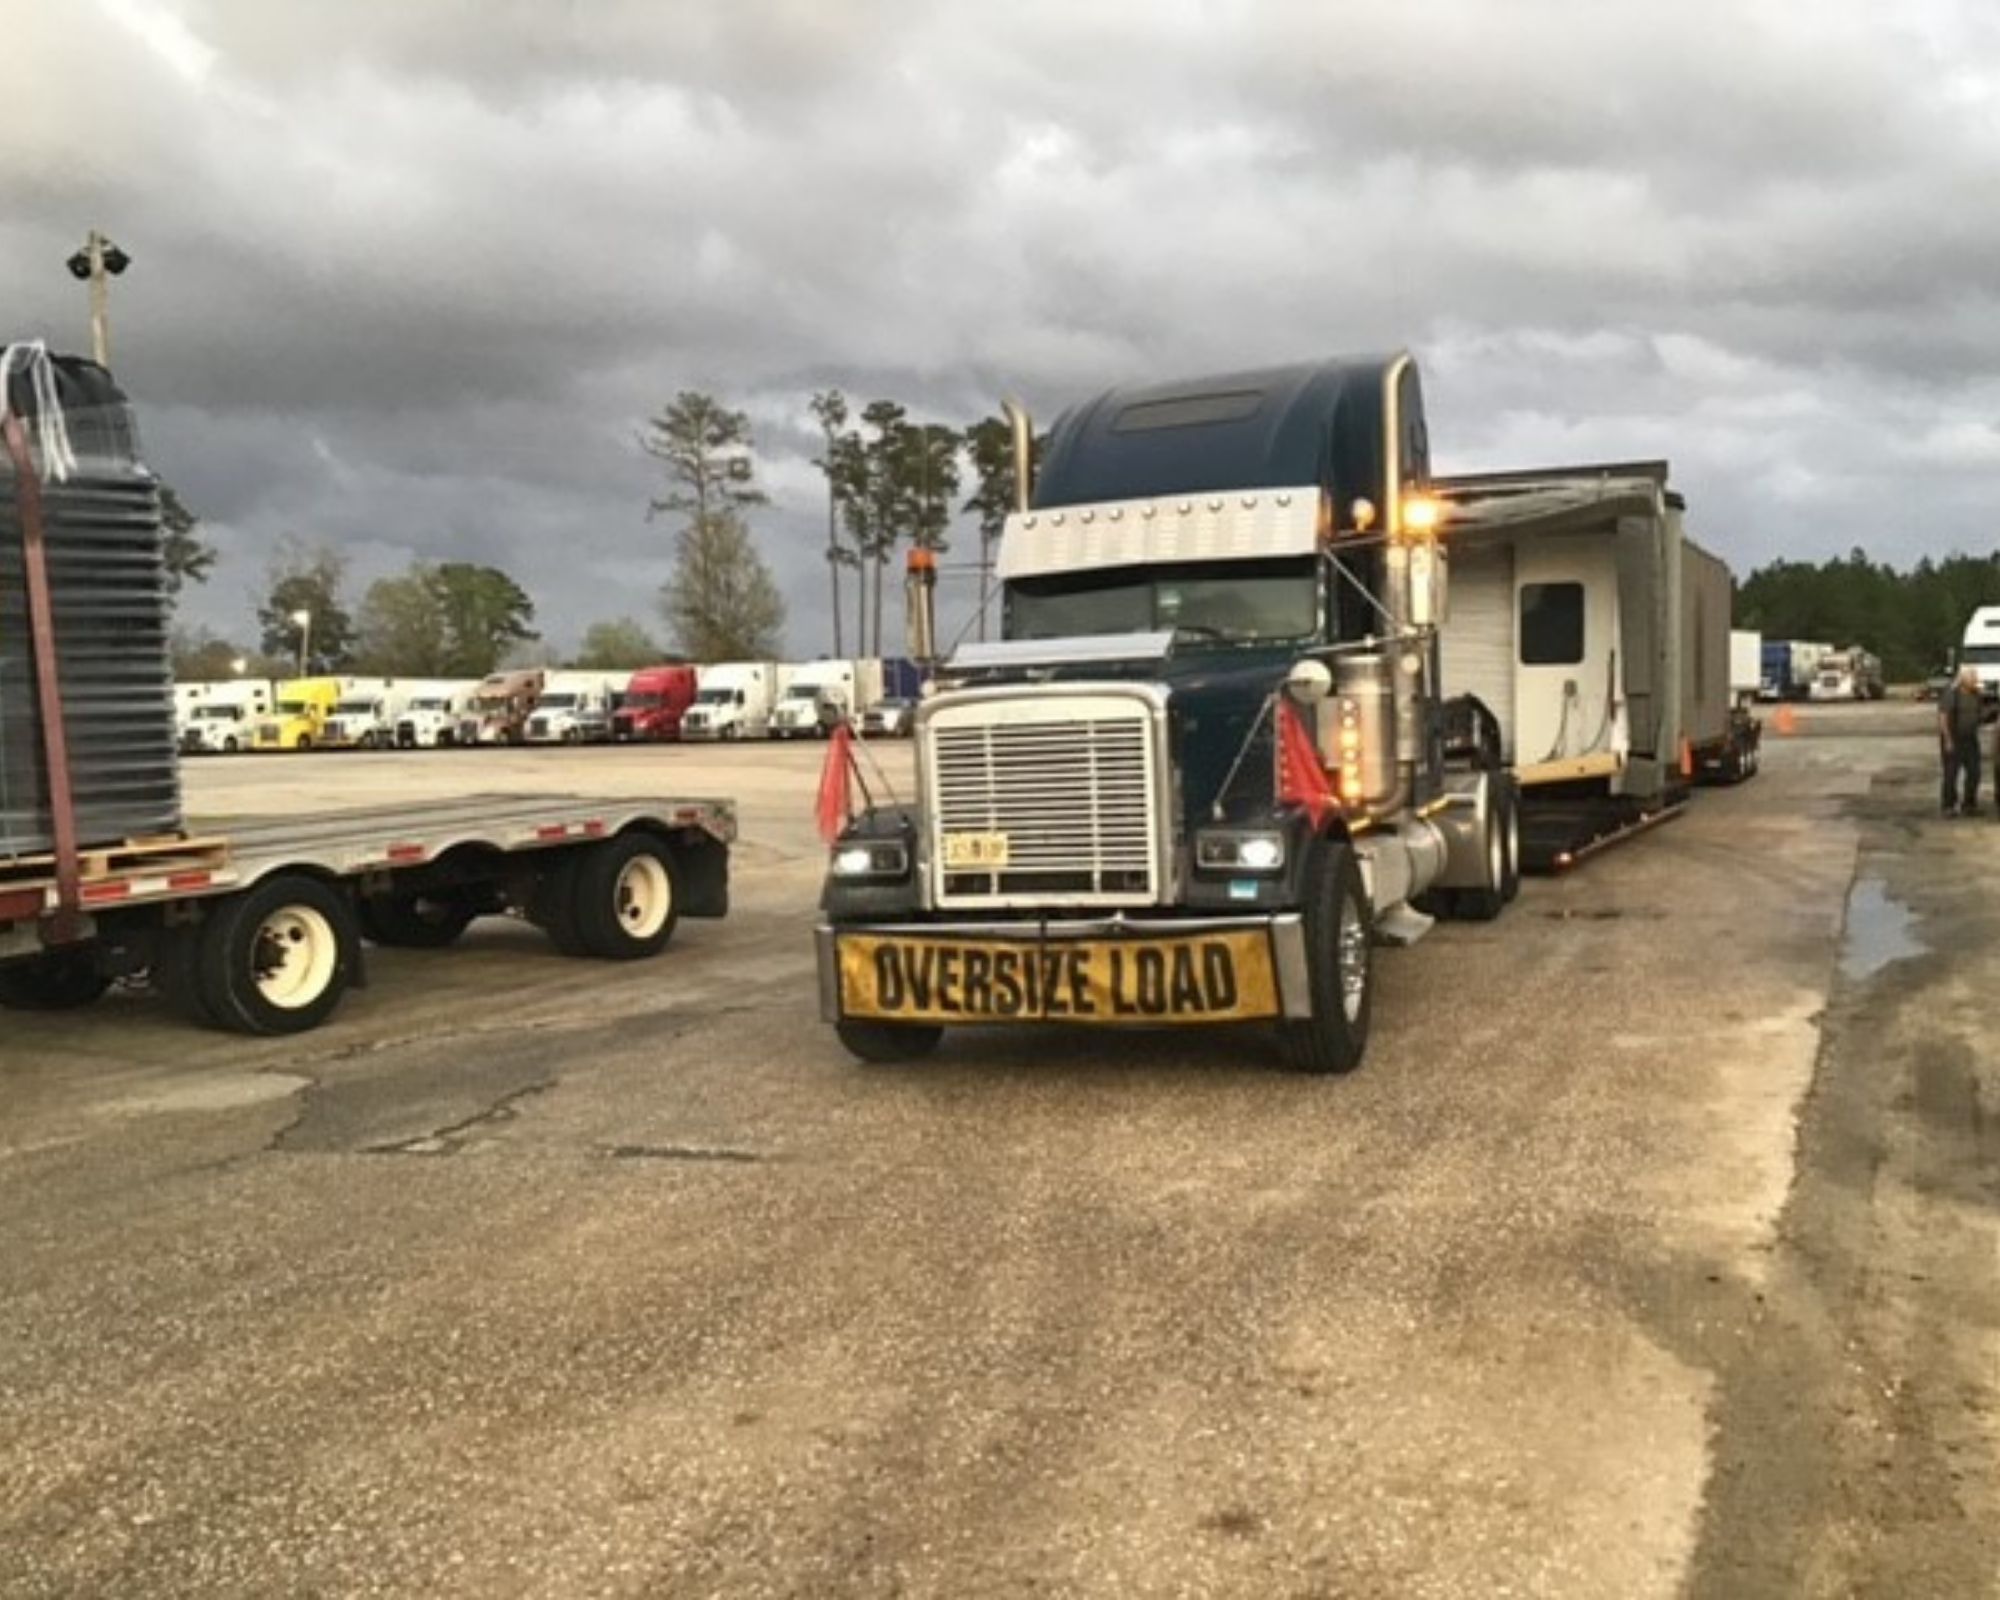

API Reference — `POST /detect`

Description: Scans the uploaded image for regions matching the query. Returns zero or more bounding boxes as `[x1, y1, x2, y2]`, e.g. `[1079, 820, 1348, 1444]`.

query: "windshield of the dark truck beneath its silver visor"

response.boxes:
[1006, 556, 1320, 644]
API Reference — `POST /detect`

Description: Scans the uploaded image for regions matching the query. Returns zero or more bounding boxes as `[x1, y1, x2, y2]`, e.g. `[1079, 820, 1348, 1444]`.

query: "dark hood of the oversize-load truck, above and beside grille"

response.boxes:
[940, 634, 1304, 832]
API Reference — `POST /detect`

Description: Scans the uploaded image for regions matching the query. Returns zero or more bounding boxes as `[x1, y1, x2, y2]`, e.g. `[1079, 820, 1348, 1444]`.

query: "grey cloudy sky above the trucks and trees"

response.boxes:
[0, 0, 2000, 654]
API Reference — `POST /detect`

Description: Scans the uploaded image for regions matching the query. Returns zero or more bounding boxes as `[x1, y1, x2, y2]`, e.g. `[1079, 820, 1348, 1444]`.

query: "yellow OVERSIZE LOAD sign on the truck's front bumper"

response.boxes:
[838, 928, 1278, 1022]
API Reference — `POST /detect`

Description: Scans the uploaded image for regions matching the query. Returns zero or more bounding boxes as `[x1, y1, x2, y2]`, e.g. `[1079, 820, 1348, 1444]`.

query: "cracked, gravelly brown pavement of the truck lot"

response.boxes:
[0, 728, 2000, 1596]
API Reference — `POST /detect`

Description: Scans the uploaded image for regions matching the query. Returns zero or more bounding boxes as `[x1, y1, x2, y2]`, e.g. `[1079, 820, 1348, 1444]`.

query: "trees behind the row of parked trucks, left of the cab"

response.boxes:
[162, 390, 1014, 678]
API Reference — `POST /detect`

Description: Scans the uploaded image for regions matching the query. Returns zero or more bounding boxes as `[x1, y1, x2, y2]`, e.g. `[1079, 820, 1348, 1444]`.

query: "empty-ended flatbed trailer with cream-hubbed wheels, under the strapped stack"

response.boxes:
[0, 796, 736, 1034]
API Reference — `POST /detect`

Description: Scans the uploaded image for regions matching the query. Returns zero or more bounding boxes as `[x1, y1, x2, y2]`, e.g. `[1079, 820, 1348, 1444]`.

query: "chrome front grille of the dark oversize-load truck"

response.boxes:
[928, 698, 1160, 906]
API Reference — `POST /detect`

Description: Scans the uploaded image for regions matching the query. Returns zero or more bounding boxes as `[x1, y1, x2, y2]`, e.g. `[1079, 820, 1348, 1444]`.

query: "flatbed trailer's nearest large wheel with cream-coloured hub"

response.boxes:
[194, 872, 360, 1034]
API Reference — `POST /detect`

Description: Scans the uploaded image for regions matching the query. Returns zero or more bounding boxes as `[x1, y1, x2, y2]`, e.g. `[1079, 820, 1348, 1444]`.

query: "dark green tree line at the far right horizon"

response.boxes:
[1736, 548, 2000, 682]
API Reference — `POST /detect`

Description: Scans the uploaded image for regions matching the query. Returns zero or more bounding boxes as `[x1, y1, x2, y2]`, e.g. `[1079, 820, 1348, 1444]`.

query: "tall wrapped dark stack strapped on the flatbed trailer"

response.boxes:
[0, 356, 180, 860]
